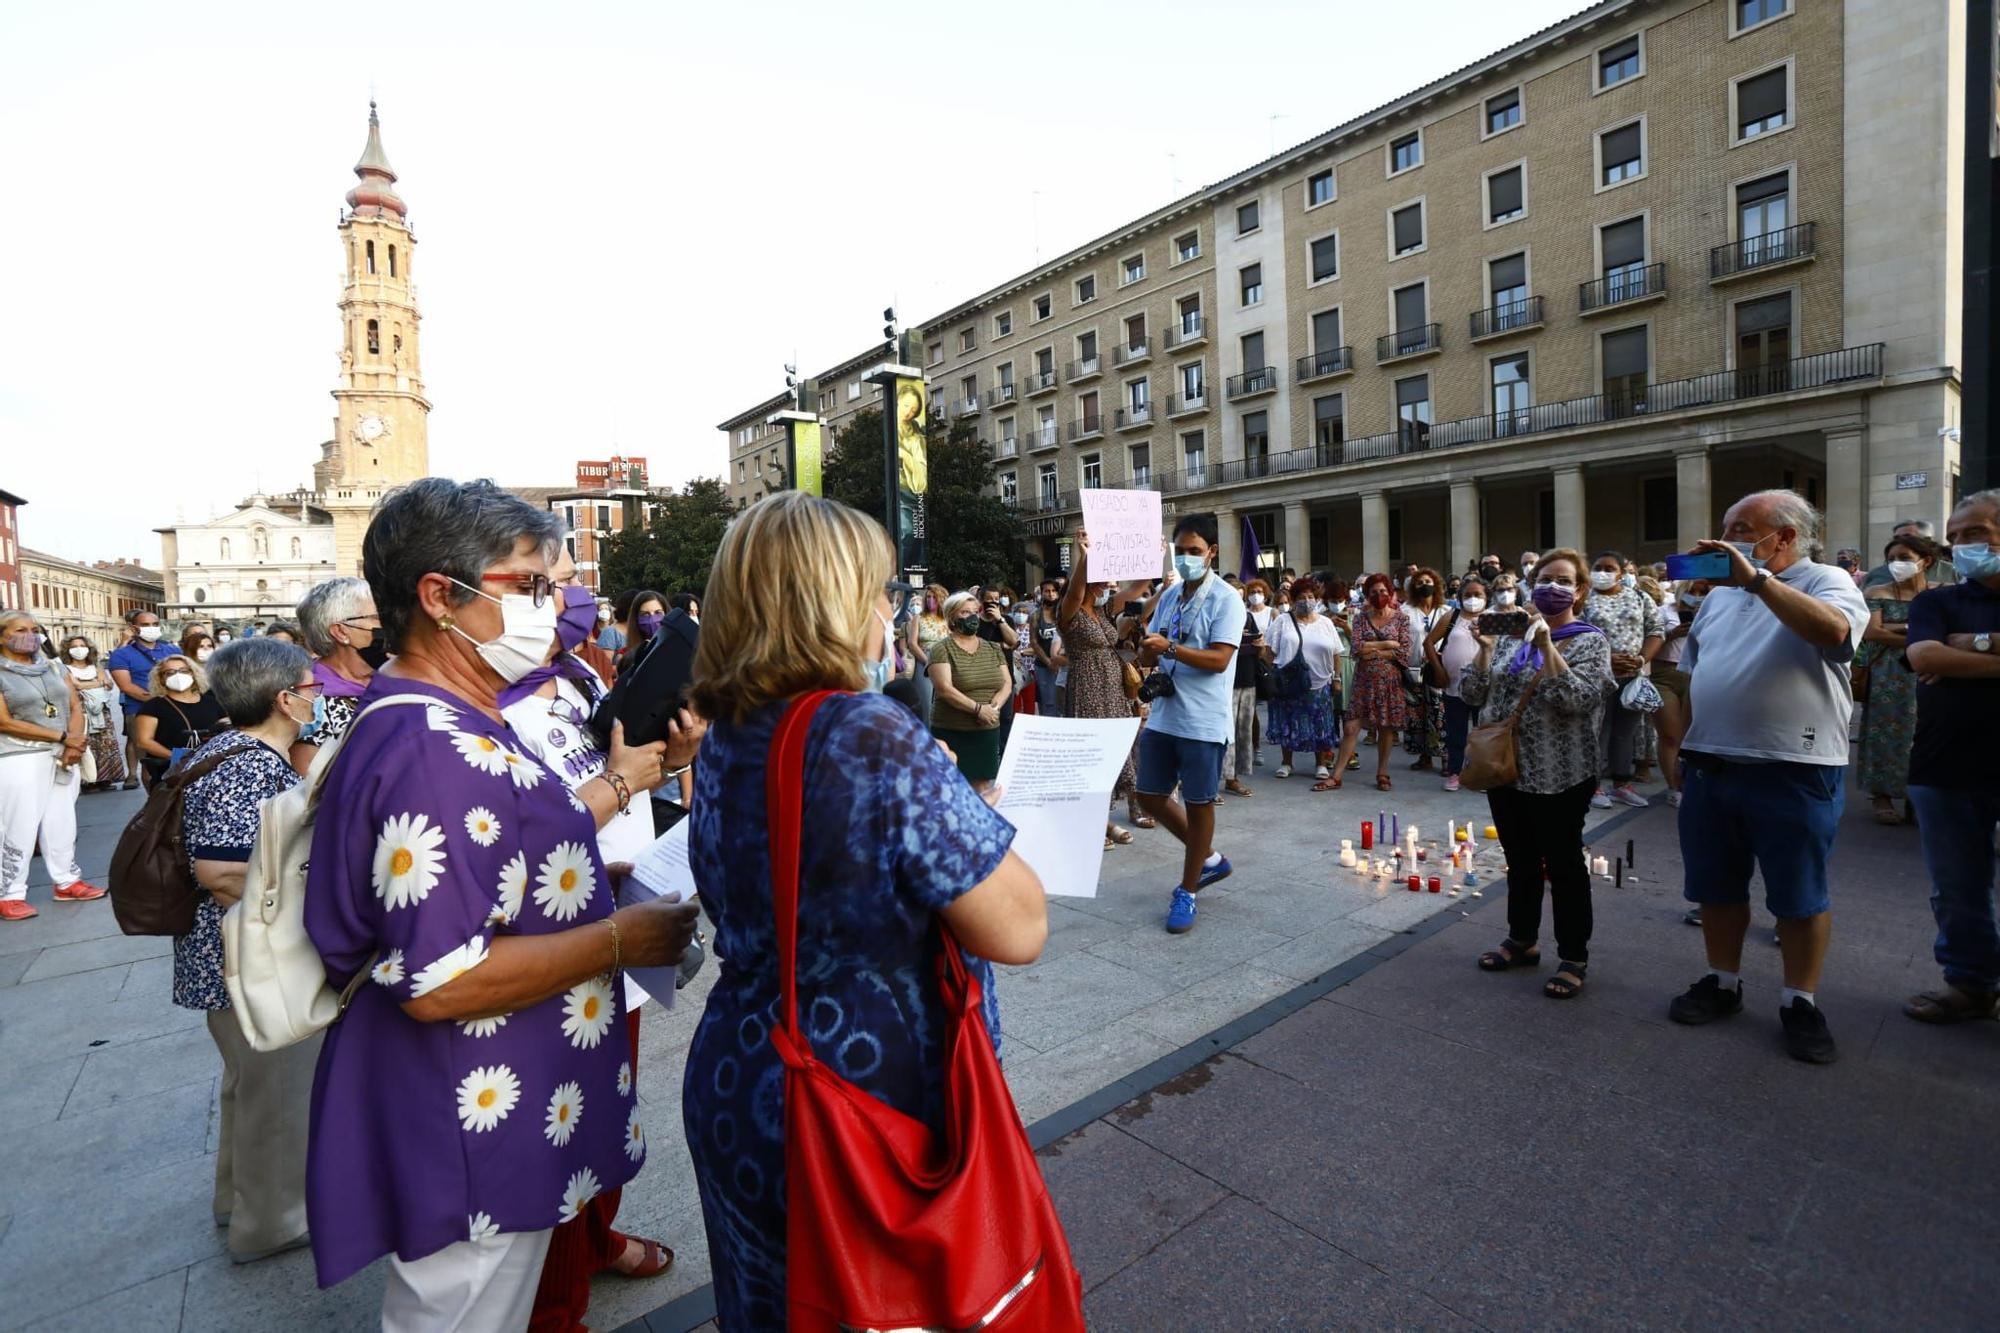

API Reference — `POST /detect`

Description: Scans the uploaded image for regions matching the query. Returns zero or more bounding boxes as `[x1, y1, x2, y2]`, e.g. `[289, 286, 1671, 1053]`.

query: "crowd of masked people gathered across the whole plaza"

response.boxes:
[0, 478, 2000, 1329]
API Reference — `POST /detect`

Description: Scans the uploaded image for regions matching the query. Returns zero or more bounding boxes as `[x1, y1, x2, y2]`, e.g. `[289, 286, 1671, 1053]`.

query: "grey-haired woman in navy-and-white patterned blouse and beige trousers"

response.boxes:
[174, 638, 320, 1263]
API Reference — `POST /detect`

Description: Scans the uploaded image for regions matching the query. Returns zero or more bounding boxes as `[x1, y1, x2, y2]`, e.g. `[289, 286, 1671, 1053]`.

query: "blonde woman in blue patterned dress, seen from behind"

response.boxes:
[682, 490, 1048, 1329]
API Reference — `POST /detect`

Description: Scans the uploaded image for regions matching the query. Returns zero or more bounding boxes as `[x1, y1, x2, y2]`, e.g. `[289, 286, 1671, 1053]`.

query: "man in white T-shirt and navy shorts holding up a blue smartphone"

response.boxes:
[1668, 490, 1868, 1065]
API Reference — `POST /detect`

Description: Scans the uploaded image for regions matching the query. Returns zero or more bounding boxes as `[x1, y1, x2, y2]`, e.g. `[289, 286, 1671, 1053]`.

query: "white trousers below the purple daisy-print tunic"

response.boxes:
[382, 1231, 550, 1333]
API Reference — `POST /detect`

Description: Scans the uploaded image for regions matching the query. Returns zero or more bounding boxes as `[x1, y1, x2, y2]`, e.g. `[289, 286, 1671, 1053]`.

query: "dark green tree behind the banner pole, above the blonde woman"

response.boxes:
[822, 408, 1026, 588]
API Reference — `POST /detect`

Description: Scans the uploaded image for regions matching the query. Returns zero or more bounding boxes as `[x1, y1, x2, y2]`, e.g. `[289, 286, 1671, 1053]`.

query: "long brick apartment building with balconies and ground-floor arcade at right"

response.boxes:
[724, 0, 1964, 574]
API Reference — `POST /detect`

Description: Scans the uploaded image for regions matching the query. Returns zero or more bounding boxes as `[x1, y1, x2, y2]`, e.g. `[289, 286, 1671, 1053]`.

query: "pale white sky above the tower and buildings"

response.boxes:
[0, 0, 1582, 564]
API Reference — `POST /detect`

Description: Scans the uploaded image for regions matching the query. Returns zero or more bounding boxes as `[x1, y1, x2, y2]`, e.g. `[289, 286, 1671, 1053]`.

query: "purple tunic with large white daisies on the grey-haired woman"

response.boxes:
[306, 675, 646, 1287]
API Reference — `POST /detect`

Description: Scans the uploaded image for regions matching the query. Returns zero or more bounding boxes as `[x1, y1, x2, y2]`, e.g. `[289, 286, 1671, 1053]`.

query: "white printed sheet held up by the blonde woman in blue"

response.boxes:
[994, 712, 1136, 899]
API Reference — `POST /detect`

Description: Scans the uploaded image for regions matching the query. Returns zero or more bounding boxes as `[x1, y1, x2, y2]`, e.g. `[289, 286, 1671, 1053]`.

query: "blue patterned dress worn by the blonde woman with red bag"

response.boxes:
[682, 695, 1014, 1329]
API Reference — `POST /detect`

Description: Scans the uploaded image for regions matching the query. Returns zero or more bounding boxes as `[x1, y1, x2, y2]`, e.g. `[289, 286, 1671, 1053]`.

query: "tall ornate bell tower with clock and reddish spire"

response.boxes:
[312, 102, 430, 574]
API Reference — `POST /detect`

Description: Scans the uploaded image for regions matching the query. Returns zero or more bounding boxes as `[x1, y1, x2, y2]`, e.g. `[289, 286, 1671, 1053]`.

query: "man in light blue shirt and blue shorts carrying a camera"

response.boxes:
[1138, 514, 1246, 935]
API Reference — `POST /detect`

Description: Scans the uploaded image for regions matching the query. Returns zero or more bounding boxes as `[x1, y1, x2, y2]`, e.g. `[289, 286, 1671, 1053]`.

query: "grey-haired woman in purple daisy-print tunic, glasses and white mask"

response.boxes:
[304, 476, 696, 1329]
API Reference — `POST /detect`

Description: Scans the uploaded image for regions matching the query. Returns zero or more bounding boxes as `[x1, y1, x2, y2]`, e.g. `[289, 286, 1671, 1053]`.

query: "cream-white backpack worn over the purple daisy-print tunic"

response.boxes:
[222, 695, 436, 1051]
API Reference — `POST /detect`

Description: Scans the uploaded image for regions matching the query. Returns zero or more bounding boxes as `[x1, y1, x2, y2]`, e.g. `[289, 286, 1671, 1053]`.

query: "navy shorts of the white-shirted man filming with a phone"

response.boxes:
[1680, 751, 1848, 921]
